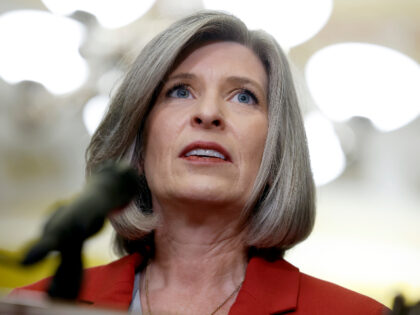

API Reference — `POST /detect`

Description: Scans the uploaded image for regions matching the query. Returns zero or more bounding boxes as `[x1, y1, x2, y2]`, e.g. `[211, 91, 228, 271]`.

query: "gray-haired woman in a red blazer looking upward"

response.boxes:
[13, 12, 385, 315]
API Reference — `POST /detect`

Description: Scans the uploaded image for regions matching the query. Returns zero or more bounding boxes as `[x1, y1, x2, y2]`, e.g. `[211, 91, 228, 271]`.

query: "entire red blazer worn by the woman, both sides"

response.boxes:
[11, 254, 388, 315]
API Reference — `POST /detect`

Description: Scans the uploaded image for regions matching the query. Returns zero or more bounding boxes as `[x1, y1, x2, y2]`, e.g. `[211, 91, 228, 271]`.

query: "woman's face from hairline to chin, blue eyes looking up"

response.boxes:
[144, 42, 268, 209]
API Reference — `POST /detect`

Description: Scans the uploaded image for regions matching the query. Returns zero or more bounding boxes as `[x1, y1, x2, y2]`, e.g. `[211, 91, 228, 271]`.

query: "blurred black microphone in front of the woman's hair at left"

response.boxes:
[21, 162, 140, 299]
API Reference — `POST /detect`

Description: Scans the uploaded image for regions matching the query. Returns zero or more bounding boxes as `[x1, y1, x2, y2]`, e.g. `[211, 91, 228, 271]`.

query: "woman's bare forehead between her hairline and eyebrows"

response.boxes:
[171, 41, 267, 88]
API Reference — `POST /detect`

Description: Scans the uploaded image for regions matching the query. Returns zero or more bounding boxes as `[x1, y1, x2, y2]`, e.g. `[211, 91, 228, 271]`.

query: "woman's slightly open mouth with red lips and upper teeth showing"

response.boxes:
[179, 141, 232, 162]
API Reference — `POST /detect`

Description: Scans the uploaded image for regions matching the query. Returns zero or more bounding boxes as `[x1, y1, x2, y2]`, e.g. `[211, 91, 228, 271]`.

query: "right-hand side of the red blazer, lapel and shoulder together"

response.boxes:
[238, 257, 387, 315]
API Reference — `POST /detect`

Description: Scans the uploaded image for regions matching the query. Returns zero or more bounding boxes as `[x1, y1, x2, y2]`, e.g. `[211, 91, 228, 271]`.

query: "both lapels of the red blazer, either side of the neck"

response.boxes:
[79, 254, 300, 315]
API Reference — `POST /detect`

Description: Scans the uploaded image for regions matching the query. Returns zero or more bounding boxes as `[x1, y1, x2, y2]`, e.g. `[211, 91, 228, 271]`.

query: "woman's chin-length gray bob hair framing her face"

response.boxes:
[86, 11, 315, 253]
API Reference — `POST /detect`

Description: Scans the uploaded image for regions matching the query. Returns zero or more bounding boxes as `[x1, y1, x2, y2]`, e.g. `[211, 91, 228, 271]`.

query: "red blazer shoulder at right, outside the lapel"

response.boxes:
[299, 273, 387, 315]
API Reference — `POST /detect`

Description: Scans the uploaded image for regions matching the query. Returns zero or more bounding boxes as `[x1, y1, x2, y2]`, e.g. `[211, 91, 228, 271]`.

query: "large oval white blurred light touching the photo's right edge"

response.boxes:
[305, 43, 420, 131]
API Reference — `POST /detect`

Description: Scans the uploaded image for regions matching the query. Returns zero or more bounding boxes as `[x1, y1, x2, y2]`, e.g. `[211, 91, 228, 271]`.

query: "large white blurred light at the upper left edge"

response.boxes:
[0, 10, 88, 94]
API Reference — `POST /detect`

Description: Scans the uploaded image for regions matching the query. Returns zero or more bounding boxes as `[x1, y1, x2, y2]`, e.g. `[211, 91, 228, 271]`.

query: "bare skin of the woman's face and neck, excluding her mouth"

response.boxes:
[140, 42, 268, 315]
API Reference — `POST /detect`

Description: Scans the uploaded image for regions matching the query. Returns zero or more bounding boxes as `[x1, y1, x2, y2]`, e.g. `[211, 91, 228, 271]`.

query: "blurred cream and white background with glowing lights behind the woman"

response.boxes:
[0, 0, 420, 306]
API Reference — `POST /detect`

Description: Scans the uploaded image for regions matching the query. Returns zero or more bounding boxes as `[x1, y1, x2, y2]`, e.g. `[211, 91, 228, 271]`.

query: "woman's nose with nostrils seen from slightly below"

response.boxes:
[191, 97, 225, 129]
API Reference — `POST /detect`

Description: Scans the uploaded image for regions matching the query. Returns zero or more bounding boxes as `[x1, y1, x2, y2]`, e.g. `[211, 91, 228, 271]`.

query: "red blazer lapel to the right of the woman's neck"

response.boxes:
[229, 257, 300, 315]
